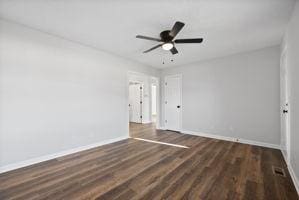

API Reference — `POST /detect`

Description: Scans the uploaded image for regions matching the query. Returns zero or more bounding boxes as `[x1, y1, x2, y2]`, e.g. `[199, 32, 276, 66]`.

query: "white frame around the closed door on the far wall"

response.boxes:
[163, 74, 184, 132]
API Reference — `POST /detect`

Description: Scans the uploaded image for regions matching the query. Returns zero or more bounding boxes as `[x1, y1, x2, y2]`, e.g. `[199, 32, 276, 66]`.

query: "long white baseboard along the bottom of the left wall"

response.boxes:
[0, 135, 129, 173]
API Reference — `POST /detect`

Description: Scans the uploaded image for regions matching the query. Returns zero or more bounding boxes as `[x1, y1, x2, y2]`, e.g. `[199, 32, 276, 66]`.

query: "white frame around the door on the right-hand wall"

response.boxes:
[280, 47, 291, 165]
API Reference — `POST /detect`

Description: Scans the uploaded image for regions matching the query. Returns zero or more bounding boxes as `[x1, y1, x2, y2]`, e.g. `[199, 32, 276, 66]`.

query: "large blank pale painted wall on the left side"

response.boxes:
[0, 20, 159, 167]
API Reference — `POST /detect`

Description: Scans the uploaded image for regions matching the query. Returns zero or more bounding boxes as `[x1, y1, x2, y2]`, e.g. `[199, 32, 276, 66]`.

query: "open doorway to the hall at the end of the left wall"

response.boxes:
[128, 72, 160, 139]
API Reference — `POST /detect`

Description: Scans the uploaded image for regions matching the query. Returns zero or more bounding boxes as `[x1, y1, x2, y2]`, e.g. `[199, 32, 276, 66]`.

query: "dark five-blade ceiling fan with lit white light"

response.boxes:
[136, 21, 203, 54]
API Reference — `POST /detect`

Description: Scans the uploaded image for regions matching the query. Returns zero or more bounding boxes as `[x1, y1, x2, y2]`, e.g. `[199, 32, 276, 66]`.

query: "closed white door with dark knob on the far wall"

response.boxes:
[164, 75, 182, 131]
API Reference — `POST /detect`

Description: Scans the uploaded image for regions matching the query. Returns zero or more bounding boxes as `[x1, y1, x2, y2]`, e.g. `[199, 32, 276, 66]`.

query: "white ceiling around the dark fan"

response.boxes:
[0, 0, 295, 68]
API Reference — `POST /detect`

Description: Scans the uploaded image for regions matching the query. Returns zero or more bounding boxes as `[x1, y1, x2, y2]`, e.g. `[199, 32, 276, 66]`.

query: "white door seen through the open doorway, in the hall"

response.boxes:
[129, 83, 142, 123]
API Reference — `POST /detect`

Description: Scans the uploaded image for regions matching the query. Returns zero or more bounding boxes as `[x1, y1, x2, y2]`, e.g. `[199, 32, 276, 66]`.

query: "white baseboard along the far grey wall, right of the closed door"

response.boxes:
[181, 130, 280, 150]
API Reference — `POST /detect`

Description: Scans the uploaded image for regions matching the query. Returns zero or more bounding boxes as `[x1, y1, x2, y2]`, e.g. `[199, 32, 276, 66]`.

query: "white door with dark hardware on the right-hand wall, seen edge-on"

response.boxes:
[280, 48, 290, 162]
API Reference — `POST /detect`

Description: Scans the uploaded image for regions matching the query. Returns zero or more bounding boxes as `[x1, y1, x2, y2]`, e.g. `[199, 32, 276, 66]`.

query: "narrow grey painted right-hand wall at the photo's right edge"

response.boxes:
[283, 1, 299, 192]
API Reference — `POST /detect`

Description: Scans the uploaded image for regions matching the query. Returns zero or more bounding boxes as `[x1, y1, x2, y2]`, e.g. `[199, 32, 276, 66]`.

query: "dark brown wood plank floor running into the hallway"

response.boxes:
[0, 124, 298, 200]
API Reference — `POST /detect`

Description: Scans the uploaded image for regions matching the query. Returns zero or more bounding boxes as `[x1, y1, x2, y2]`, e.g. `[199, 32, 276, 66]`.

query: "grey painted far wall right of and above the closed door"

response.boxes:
[161, 46, 280, 145]
